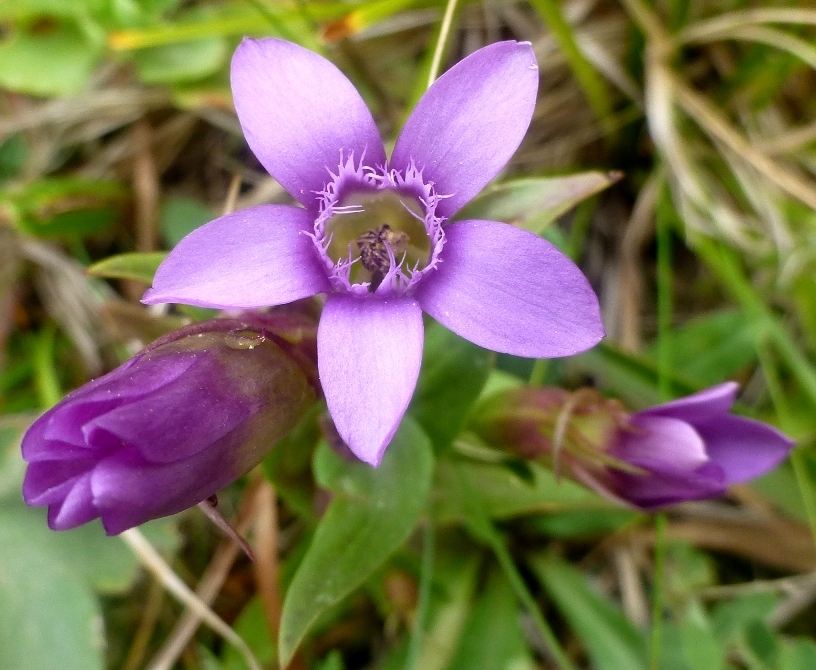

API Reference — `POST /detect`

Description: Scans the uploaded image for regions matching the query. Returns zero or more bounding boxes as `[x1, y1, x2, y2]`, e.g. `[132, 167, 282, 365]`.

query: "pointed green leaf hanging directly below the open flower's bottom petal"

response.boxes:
[279, 418, 433, 666]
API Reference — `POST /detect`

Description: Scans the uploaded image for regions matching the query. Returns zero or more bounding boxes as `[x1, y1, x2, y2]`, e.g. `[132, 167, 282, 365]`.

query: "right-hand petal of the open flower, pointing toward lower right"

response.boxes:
[416, 221, 604, 358]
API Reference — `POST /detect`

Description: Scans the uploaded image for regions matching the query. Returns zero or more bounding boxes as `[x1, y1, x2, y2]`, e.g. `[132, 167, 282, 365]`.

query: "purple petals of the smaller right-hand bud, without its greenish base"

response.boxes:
[600, 382, 793, 509]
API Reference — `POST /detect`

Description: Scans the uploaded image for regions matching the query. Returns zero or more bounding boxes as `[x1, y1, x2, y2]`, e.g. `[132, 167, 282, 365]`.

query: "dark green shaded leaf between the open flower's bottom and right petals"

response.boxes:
[409, 323, 492, 449]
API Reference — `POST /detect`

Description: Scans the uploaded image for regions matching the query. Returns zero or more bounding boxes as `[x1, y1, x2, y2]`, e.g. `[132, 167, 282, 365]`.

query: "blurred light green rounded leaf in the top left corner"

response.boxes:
[0, 20, 102, 95]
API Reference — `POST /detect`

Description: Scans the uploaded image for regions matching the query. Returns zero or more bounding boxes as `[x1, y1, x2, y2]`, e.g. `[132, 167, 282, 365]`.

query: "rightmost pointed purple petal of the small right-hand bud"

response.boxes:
[697, 416, 794, 484]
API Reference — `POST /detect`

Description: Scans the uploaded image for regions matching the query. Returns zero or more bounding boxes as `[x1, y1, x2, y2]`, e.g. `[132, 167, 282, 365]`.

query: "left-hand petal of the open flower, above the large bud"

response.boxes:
[142, 205, 329, 309]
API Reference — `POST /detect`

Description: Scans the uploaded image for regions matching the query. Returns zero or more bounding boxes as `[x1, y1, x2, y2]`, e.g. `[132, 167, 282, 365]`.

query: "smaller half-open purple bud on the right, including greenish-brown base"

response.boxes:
[476, 382, 793, 509]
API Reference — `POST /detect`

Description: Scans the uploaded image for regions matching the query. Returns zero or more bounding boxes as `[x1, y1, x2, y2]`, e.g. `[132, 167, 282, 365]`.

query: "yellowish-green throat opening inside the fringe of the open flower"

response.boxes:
[325, 189, 432, 292]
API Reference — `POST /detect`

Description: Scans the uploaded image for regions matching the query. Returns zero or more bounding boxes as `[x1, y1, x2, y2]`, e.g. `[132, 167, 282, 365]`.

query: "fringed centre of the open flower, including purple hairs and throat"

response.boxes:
[313, 159, 444, 295]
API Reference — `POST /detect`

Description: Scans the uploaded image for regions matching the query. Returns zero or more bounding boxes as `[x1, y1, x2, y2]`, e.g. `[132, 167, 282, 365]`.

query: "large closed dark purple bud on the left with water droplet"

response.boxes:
[22, 314, 317, 535]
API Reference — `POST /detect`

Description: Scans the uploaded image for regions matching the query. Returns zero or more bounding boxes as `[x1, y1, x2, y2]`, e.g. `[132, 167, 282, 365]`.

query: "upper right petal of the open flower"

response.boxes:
[391, 42, 538, 217]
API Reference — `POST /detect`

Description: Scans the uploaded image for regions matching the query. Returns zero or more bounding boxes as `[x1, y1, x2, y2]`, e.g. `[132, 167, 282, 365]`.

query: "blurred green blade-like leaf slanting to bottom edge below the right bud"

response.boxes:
[530, 554, 647, 670]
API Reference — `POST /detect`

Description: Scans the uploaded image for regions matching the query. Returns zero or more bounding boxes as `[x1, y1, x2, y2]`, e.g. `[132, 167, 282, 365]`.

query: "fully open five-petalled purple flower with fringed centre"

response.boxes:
[143, 39, 604, 465]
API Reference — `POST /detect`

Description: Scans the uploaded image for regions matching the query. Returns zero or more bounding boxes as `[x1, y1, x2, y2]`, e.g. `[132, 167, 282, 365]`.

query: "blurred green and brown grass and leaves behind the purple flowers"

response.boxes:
[0, 0, 816, 670]
